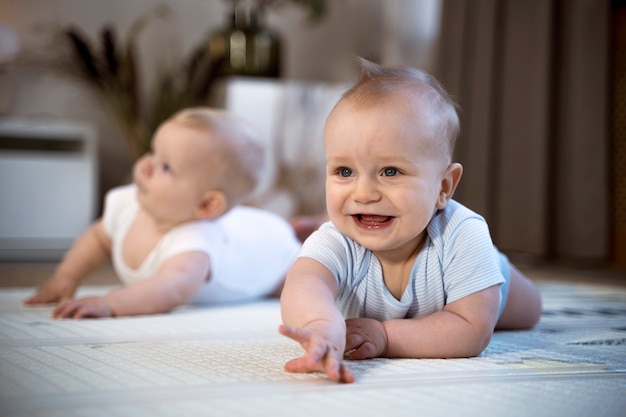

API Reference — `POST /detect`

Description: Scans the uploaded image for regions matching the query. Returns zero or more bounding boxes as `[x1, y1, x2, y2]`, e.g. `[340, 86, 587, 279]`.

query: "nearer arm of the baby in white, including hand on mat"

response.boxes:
[53, 252, 210, 318]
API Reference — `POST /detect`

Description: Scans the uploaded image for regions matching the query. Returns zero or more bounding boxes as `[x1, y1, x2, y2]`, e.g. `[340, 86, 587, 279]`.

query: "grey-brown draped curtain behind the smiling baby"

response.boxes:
[438, 0, 611, 263]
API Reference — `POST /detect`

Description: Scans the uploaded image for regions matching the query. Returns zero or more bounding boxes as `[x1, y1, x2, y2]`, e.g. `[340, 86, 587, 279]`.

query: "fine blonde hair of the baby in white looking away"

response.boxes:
[167, 107, 265, 209]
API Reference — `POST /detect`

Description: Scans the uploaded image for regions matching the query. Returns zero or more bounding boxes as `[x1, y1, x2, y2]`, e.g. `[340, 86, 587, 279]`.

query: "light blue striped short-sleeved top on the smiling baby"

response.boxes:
[298, 200, 509, 321]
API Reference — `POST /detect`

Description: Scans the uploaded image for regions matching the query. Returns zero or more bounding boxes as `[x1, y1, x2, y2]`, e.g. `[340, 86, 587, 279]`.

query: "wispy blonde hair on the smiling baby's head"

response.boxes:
[340, 58, 460, 163]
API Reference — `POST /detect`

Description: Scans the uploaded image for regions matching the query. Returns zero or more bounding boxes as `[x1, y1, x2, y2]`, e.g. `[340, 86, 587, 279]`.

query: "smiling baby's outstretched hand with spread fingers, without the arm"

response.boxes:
[279, 324, 354, 382]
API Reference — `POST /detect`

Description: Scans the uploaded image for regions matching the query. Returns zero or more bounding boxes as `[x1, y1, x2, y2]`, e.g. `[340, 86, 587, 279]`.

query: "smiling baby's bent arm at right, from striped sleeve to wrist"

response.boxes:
[376, 285, 500, 358]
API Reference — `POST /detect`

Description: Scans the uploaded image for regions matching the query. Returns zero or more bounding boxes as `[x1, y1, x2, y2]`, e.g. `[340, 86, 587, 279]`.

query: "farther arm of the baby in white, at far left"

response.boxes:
[24, 220, 111, 305]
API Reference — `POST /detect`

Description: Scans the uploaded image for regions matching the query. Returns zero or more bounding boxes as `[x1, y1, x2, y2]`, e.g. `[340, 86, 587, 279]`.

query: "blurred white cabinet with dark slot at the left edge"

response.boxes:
[0, 119, 98, 261]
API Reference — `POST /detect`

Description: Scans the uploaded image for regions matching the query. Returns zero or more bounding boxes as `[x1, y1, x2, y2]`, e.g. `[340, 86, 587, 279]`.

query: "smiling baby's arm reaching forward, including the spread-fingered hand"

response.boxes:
[279, 258, 354, 382]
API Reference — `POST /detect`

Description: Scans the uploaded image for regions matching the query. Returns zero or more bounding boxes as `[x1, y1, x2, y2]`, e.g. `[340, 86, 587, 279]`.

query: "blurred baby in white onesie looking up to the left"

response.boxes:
[25, 108, 300, 318]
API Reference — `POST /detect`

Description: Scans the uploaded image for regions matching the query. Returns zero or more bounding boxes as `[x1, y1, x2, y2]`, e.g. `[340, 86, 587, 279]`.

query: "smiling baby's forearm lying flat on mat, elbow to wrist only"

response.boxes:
[383, 311, 493, 358]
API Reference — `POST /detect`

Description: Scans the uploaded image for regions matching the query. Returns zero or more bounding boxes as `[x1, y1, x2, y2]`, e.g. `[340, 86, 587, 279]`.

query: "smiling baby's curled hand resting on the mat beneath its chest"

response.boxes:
[346, 318, 387, 359]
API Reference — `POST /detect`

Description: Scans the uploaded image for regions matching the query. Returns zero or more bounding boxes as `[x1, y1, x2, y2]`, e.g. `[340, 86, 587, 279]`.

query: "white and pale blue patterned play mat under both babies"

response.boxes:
[0, 281, 626, 417]
